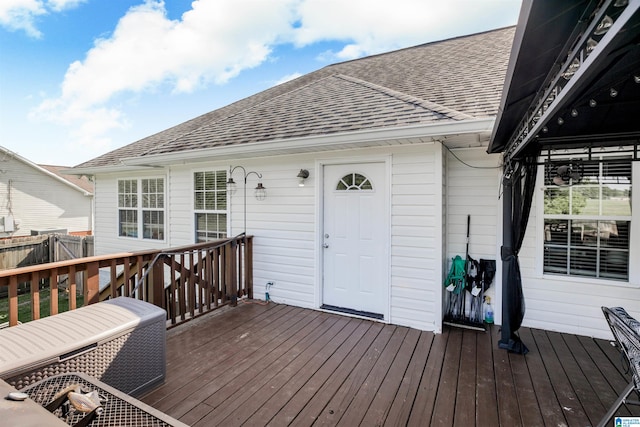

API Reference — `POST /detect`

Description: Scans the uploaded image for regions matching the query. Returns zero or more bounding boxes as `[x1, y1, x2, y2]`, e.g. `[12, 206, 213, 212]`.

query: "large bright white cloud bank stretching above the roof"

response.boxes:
[30, 0, 515, 155]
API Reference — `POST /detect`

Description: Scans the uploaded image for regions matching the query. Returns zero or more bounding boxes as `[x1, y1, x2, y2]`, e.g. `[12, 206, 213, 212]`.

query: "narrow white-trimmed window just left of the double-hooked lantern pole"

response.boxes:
[193, 171, 227, 242]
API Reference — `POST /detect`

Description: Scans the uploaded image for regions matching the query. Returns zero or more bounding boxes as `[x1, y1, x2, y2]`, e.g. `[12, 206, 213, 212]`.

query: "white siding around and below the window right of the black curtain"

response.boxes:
[519, 162, 640, 339]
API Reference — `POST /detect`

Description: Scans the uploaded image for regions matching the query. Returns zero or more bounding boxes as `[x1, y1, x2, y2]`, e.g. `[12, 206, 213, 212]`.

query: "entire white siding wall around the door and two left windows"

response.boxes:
[96, 144, 443, 330]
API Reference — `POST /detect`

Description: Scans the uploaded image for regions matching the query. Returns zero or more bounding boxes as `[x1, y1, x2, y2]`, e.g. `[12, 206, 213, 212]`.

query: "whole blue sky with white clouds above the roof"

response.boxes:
[0, 0, 520, 166]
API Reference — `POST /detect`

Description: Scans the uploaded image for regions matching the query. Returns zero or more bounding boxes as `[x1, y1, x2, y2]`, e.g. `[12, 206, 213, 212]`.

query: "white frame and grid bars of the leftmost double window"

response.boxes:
[116, 176, 167, 242]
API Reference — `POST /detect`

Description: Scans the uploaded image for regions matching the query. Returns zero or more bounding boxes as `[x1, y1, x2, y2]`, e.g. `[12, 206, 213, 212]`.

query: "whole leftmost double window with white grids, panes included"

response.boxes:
[118, 178, 165, 240]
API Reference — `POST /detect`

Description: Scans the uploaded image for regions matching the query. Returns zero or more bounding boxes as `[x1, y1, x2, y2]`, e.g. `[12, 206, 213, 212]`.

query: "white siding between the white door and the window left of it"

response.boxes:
[230, 156, 319, 308]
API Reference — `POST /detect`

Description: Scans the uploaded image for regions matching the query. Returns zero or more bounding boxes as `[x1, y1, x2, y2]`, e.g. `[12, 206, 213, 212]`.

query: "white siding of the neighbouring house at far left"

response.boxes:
[0, 156, 92, 237]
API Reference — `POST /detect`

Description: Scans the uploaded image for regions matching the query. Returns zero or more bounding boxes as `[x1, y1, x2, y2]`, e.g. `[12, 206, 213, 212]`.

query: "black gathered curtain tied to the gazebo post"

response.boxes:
[498, 156, 537, 354]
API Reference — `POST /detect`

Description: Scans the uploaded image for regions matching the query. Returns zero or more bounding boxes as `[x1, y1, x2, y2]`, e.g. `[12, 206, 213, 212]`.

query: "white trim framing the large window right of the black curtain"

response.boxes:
[532, 155, 640, 288]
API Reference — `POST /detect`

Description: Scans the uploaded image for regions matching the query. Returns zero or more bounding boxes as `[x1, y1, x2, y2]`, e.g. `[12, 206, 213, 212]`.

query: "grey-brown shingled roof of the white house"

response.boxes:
[76, 27, 515, 168]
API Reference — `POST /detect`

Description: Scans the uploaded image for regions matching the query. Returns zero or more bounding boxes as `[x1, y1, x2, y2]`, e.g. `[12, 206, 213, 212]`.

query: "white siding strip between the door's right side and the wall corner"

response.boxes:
[391, 145, 442, 332]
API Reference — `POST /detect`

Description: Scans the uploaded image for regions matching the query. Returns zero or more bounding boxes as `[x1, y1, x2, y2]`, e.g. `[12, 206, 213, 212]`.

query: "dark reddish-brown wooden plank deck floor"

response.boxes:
[142, 304, 640, 427]
